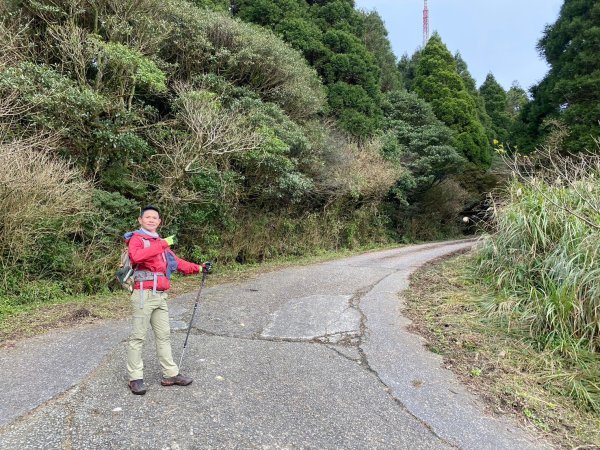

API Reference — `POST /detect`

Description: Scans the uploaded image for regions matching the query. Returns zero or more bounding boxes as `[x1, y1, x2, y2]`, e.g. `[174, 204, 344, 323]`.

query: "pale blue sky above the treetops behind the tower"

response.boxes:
[355, 0, 563, 89]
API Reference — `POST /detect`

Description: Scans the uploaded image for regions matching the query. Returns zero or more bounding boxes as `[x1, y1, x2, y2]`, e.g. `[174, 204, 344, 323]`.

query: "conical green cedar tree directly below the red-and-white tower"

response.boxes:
[414, 33, 491, 167]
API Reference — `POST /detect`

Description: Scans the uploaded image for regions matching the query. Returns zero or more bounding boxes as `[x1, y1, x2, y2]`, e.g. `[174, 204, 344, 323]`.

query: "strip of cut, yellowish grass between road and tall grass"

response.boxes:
[406, 251, 600, 450]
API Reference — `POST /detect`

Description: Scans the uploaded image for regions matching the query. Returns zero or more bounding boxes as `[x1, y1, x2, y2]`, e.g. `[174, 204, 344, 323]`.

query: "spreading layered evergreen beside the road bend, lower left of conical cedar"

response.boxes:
[382, 91, 466, 237]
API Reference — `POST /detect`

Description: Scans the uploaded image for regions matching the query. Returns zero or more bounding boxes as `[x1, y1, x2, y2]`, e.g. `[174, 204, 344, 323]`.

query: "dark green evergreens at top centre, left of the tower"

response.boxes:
[235, 0, 382, 138]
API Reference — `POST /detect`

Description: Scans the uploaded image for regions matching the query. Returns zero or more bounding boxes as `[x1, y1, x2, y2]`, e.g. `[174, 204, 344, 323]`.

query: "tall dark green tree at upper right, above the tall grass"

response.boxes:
[519, 0, 600, 152]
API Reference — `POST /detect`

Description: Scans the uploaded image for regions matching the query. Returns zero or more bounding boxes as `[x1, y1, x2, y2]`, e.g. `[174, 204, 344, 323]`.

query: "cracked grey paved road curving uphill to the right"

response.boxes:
[0, 241, 547, 450]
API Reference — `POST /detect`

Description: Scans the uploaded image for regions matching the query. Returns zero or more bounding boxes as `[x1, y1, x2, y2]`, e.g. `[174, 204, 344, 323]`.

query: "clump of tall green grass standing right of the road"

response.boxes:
[477, 142, 600, 410]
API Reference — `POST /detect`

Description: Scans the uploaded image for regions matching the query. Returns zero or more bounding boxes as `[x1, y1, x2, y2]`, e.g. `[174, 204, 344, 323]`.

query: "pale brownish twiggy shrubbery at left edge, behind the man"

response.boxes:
[0, 136, 93, 309]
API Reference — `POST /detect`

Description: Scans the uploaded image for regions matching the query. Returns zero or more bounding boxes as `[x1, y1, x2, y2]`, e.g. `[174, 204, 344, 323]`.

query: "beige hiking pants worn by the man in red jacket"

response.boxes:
[127, 289, 179, 381]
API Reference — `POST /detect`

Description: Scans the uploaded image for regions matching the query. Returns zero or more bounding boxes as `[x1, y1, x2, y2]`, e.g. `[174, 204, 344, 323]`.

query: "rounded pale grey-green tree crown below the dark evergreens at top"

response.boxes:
[157, 1, 325, 118]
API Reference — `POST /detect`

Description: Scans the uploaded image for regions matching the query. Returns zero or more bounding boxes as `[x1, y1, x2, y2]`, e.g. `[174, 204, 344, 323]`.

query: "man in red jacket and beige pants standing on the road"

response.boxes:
[125, 206, 204, 395]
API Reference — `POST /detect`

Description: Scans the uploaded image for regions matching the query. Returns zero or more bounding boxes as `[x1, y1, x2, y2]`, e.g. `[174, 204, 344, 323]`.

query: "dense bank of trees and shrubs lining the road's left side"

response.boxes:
[0, 0, 482, 314]
